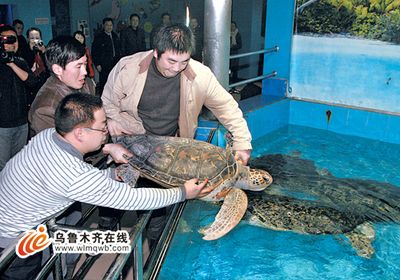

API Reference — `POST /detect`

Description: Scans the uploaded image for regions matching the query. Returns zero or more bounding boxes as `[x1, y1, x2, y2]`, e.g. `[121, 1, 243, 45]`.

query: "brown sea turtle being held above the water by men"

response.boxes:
[114, 135, 272, 240]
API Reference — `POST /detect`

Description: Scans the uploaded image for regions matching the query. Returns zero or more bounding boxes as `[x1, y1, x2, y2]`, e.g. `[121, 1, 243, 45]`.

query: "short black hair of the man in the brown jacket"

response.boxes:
[45, 36, 86, 69]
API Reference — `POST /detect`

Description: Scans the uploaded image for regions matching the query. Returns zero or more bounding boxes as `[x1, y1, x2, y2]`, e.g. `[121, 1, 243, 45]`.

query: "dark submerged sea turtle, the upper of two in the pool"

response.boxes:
[251, 154, 400, 223]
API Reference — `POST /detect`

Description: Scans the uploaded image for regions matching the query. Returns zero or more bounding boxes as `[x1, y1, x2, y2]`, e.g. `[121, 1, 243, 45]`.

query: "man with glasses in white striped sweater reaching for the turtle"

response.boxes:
[0, 93, 210, 279]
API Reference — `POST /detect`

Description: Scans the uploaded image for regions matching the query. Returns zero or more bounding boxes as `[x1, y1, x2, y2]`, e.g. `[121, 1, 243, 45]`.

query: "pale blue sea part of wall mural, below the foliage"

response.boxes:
[289, 35, 400, 112]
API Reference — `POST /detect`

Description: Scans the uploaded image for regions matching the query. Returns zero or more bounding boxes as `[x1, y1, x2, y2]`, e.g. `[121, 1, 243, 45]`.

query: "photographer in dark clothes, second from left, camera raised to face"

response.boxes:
[26, 27, 50, 105]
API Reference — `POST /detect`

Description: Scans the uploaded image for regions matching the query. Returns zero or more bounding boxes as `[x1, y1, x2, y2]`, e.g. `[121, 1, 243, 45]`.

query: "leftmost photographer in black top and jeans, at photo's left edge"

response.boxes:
[0, 25, 37, 171]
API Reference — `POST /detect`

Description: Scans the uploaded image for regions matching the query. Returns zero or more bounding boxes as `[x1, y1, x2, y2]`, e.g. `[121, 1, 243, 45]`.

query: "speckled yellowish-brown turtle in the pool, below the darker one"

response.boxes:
[246, 193, 375, 258]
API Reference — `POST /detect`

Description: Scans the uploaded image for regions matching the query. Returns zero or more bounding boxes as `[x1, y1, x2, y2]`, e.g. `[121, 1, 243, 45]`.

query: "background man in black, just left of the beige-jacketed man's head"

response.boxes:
[92, 18, 121, 96]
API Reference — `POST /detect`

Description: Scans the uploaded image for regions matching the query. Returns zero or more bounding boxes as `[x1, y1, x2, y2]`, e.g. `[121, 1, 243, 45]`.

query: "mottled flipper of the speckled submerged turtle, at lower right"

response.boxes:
[345, 222, 375, 259]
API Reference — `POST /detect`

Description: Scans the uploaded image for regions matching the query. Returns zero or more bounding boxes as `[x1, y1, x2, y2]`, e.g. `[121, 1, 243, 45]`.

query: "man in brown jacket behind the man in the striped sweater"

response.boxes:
[29, 36, 95, 134]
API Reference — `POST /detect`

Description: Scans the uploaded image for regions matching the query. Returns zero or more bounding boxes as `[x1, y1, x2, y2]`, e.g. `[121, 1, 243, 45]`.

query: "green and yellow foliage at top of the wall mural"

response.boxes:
[295, 0, 400, 44]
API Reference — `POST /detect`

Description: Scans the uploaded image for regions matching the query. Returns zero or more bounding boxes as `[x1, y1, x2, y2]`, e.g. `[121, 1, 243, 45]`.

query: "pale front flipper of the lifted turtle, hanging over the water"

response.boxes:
[203, 188, 247, 240]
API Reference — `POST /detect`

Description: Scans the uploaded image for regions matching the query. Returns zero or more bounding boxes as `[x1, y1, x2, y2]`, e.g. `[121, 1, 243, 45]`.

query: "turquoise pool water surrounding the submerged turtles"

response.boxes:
[158, 126, 400, 280]
